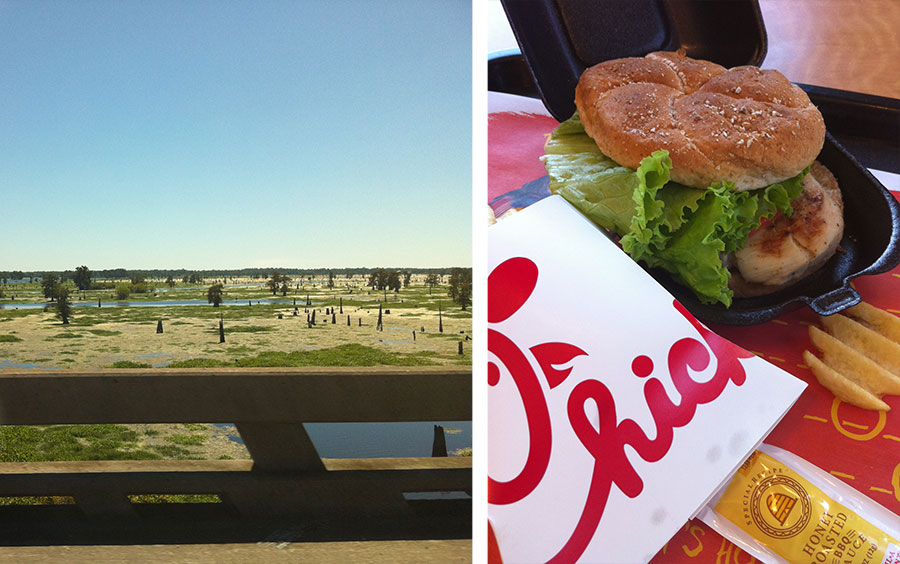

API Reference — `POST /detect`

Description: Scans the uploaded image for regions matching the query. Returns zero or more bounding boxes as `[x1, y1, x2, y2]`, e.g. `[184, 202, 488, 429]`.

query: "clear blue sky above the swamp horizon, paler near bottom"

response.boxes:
[0, 0, 472, 270]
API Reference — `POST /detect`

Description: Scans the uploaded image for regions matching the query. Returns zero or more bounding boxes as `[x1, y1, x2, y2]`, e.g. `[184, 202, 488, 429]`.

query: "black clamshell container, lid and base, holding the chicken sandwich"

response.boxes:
[502, 0, 900, 325]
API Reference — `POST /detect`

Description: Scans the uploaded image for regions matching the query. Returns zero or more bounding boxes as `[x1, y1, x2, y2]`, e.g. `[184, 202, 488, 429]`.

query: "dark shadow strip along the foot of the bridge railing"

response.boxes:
[0, 499, 472, 546]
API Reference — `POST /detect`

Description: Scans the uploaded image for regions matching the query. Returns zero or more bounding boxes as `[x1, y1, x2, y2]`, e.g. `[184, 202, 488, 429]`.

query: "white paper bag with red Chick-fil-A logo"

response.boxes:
[488, 196, 805, 564]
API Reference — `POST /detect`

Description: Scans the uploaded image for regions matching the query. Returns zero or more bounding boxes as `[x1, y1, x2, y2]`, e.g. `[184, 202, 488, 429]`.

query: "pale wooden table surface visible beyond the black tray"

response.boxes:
[487, 0, 900, 98]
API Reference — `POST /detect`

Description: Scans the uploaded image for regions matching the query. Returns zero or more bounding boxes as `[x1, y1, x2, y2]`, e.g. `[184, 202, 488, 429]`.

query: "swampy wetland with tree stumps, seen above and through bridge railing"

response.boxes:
[0, 274, 472, 476]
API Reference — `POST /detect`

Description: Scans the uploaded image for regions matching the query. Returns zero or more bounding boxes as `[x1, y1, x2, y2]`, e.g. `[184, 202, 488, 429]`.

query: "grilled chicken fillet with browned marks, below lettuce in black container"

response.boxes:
[729, 161, 844, 297]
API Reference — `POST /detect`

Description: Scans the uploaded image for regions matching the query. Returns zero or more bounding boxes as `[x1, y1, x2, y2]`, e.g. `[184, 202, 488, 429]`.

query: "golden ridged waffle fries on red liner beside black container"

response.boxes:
[803, 302, 900, 411]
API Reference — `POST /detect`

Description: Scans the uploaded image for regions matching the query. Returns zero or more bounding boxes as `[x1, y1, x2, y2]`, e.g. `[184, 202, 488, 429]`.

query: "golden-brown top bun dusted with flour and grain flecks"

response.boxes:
[575, 52, 825, 190]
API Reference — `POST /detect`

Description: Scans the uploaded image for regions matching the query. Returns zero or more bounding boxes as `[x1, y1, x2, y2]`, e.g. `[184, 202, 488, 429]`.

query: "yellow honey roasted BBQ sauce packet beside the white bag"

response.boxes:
[697, 444, 900, 564]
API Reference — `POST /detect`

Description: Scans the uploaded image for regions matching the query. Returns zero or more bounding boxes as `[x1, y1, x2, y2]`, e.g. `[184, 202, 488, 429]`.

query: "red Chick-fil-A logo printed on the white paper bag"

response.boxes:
[488, 257, 753, 563]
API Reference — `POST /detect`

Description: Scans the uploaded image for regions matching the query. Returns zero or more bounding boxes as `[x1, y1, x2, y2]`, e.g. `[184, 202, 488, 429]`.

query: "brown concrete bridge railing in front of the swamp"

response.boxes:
[0, 367, 472, 519]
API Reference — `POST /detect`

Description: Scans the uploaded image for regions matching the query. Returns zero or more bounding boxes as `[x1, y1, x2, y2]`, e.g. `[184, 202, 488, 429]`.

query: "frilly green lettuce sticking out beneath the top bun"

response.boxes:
[543, 113, 808, 306]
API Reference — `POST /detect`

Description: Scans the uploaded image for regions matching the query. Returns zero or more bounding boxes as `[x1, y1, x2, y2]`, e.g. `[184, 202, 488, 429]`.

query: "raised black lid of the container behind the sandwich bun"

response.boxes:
[503, 0, 766, 121]
